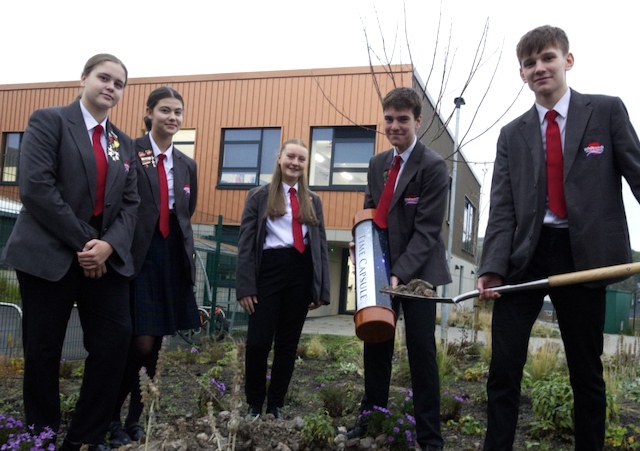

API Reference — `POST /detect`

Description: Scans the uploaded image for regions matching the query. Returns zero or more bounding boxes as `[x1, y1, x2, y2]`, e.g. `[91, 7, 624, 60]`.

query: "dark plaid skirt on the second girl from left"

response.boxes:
[131, 214, 200, 337]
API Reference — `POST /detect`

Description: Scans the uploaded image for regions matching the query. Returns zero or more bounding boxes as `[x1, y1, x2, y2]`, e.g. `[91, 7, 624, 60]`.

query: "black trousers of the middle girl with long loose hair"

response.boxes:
[245, 246, 313, 407]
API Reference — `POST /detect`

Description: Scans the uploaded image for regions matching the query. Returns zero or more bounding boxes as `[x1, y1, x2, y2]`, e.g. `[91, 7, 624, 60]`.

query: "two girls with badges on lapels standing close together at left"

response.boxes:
[3, 54, 199, 451]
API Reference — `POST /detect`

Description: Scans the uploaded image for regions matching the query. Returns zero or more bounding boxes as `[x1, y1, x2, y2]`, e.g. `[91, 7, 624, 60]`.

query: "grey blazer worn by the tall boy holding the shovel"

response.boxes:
[479, 90, 640, 286]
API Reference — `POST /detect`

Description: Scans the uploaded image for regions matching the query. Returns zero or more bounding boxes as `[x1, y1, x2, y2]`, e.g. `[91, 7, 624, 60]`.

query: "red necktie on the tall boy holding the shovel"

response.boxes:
[545, 110, 567, 218]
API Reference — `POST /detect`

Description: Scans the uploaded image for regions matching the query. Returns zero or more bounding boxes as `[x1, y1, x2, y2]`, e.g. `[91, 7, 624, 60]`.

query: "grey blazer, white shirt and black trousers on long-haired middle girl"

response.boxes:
[236, 184, 329, 410]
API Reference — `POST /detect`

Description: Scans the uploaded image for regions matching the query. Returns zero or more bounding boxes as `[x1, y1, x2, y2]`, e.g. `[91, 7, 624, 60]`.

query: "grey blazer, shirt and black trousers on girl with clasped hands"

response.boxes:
[3, 100, 139, 445]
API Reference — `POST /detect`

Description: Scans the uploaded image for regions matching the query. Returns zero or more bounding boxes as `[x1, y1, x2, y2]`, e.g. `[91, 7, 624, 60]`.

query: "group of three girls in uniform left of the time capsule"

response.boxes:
[3, 54, 336, 451]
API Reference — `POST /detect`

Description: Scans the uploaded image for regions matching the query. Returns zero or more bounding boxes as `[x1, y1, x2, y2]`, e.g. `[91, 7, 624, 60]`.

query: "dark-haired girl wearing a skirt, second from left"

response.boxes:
[109, 86, 200, 448]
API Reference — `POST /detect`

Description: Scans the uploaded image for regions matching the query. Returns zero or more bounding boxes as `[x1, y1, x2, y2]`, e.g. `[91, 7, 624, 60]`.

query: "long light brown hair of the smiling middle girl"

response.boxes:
[265, 138, 318, 225]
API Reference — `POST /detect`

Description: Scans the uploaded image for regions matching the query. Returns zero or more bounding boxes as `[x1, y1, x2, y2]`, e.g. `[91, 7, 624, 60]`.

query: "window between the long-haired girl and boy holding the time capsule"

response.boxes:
[309, 126, 376, 188]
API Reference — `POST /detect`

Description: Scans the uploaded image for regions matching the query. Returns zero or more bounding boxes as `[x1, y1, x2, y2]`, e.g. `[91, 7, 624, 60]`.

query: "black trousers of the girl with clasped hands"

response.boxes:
[17, 260, 131, 444]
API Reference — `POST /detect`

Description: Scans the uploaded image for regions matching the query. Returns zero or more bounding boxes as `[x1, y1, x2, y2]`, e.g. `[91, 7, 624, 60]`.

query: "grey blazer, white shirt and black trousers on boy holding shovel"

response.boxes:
[479, 90, 640, 451]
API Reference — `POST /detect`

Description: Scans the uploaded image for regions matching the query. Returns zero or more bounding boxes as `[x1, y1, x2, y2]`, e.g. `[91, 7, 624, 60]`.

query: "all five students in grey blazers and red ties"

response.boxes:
[4, 22, 640, 451]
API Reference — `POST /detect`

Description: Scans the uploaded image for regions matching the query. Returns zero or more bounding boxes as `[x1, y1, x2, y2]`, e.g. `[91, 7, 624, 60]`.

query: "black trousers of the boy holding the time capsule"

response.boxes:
[360, 298, 444, 447]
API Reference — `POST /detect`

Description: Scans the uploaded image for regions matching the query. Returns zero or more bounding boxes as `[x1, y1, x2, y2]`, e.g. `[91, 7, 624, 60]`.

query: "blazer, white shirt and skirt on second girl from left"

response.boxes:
[131, 135, 200, 336]
